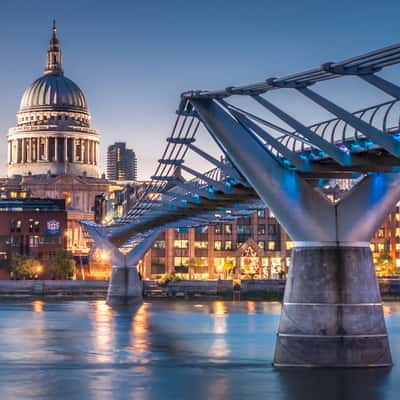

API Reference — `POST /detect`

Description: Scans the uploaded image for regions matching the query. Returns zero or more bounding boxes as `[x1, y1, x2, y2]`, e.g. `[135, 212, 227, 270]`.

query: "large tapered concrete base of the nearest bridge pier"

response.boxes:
[274, 247, 392, 367]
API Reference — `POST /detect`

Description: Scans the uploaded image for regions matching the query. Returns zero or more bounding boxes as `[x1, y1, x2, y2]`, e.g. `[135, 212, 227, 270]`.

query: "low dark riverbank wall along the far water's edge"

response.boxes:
[0, 279, 400, 301]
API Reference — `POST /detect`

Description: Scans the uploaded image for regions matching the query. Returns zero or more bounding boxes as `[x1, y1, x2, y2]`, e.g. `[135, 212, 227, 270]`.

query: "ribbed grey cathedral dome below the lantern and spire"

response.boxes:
[19, 73, 88, 113]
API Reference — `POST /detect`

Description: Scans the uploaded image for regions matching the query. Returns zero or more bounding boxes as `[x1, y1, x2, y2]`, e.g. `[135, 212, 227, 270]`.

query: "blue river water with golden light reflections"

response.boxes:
[0, 301, 400, 400]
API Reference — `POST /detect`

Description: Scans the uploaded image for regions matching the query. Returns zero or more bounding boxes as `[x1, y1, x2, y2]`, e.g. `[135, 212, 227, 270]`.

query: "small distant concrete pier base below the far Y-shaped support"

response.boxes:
[107, 265, 143, 306]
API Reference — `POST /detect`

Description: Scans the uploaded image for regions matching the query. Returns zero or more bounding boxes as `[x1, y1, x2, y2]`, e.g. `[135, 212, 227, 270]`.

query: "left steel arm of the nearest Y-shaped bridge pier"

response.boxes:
[191, 99, 335, 241]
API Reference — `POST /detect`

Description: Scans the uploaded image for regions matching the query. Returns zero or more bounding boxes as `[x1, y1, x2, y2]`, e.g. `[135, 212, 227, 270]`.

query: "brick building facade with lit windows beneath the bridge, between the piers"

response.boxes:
[139, 209, 293, 279]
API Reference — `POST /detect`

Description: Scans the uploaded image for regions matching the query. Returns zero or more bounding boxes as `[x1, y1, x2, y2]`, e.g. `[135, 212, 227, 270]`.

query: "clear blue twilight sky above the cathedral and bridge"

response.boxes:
[0, 0, 400, 179]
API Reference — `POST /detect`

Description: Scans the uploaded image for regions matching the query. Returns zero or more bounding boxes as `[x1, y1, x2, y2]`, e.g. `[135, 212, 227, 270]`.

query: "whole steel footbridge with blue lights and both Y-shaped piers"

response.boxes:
[82, 44, 400, 367]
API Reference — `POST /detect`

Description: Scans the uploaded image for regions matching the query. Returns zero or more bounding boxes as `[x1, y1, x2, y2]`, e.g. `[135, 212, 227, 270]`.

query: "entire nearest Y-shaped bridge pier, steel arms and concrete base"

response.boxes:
[190, 98, 400, 367]
